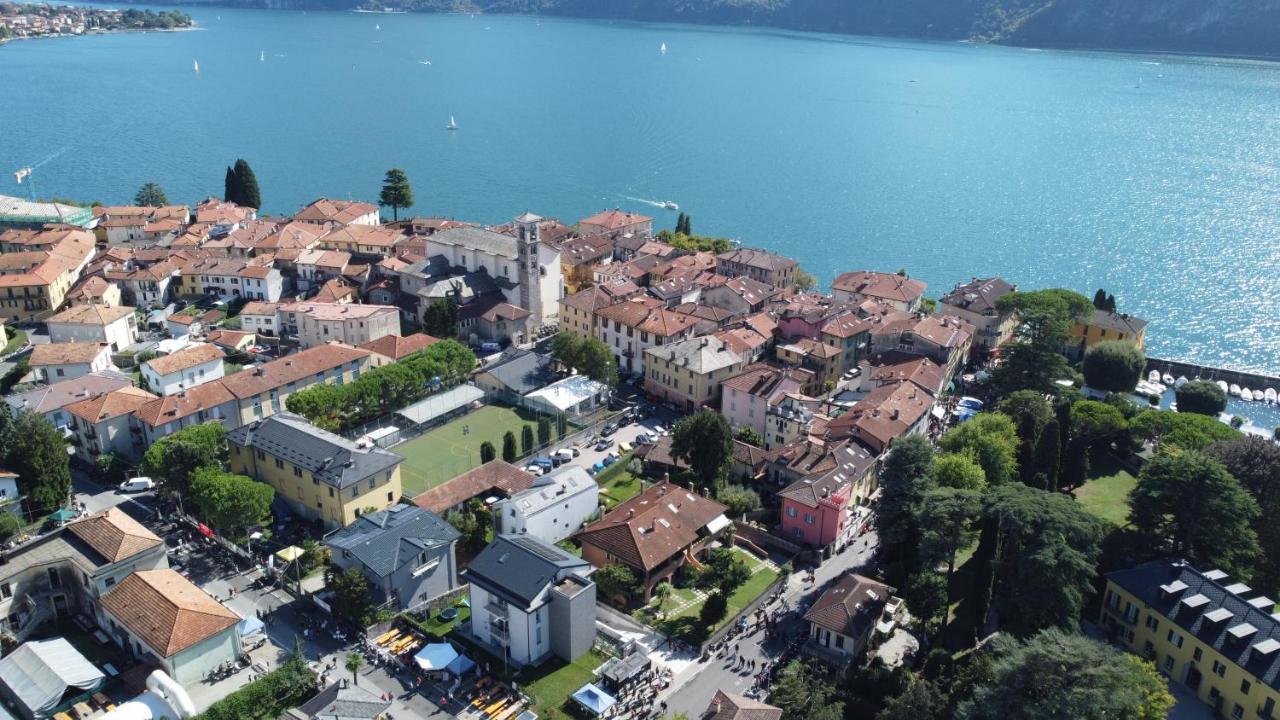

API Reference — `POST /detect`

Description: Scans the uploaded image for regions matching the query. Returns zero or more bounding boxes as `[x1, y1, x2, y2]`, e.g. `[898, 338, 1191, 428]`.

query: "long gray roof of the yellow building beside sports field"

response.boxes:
[227, 413, 404, 489]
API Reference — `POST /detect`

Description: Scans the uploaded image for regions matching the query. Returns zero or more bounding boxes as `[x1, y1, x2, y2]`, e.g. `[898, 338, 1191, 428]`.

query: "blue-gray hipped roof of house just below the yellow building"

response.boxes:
[324, 503, 458, 578]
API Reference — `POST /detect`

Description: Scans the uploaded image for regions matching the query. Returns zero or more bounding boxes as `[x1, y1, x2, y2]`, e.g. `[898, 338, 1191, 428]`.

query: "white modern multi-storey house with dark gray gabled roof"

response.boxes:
[463, 534, 595, 665]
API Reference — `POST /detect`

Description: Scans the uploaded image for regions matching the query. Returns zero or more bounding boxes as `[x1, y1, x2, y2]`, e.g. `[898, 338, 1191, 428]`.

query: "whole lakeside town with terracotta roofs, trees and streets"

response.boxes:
[0, 172, 1280, 720]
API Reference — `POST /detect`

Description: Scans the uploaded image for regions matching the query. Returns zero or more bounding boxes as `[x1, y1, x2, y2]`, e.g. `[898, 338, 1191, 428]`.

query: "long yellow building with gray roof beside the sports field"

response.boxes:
[227, 413, 404, 529]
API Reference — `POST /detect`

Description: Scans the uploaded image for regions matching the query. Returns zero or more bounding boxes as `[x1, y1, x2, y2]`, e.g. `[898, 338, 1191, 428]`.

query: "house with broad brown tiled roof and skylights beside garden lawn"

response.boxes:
[575, 480, 732, 600]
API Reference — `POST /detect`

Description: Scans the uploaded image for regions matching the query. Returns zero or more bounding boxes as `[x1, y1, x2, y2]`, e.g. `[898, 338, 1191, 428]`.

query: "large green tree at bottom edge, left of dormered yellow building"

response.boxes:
[956, 630, 1174, 720]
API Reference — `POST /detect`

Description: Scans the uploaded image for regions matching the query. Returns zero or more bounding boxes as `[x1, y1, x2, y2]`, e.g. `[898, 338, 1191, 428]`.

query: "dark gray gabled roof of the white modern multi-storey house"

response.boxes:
[463, 534, 591, 607]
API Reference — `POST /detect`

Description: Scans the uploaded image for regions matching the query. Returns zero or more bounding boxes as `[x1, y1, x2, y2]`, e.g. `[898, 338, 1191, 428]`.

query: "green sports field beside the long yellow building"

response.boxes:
[393, 405, 540, 497]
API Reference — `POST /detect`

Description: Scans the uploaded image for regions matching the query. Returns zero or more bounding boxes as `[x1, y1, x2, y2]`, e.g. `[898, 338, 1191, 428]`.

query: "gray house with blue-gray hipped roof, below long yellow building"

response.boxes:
[324, 503, 460, 609]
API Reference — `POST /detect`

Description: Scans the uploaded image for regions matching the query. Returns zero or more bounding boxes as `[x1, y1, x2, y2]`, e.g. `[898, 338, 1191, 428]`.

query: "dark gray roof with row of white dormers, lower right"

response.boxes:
[1107, 560, 1280, 689]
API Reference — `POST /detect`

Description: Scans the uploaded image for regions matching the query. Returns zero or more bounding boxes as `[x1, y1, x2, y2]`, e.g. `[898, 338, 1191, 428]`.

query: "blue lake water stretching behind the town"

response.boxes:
[0, 9, 1280, 372]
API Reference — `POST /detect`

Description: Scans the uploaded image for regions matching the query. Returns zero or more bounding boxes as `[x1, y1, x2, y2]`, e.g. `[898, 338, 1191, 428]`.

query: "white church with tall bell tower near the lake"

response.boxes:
[426, 213, 564, 325]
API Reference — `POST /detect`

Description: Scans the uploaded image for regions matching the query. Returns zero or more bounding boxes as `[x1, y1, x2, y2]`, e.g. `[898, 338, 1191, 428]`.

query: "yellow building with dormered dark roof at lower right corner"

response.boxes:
[1100, 560, 1280, 720]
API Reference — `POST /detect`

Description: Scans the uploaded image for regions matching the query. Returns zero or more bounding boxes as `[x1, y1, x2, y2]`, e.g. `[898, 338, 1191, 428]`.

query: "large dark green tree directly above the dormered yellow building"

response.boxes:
[1129, 448, 1260, 579]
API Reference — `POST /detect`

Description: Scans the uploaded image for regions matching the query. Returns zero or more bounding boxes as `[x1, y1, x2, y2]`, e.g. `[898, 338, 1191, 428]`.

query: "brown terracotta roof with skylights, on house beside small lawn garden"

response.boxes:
[576, 482, 726, 573]
